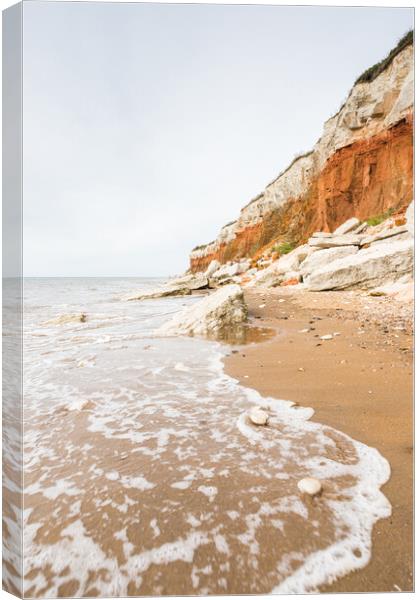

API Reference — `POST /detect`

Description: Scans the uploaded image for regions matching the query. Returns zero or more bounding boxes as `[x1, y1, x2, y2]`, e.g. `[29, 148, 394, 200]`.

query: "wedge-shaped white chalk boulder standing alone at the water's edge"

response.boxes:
[157, 284, 247, 336]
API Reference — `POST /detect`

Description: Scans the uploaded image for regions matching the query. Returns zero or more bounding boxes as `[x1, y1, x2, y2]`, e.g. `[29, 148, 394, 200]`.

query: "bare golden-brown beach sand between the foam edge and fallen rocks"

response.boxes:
[225, 288, 413, 592]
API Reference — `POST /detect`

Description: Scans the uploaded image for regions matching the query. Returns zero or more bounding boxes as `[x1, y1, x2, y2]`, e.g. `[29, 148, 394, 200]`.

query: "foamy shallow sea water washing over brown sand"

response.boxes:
[6, 278, 390, 597]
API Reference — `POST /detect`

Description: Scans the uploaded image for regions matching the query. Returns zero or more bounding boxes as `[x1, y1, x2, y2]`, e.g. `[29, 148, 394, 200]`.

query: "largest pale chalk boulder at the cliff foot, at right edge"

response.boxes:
[305, 240, 414, 292]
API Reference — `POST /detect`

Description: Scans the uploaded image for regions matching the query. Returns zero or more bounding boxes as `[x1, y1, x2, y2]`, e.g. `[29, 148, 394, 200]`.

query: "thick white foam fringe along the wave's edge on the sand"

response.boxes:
[212, 350, 392, 594]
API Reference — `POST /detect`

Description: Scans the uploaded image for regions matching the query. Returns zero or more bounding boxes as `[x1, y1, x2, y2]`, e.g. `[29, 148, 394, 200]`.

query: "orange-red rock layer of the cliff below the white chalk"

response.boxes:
[190, 115, 413, 272]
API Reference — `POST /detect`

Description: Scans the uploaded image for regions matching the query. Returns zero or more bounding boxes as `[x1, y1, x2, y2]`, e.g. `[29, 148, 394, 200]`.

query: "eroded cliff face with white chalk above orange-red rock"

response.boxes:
[190, 45, 414, 272]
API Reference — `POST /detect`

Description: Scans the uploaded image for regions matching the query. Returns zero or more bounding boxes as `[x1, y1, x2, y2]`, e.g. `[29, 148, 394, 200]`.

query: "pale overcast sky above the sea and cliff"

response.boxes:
[23, 1, 413, 277]
